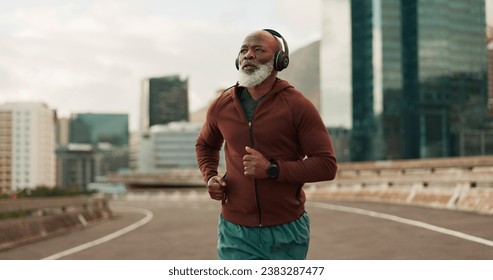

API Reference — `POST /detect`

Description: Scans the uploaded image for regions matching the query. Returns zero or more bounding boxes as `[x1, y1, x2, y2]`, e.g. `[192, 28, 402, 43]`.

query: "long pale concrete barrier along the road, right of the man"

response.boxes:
[305, 156, 493, 214]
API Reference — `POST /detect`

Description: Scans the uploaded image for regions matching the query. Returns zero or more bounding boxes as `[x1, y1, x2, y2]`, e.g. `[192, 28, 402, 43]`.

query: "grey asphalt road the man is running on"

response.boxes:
[0, 190, 493, 260]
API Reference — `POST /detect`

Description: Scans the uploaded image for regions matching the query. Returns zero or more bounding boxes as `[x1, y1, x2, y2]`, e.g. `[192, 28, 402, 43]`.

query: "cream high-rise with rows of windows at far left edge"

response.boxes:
[0, 102, 56, 192]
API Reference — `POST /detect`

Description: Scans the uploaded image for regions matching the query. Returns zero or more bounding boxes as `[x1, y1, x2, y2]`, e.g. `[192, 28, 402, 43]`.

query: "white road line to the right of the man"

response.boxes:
[307, 202, 493, 247]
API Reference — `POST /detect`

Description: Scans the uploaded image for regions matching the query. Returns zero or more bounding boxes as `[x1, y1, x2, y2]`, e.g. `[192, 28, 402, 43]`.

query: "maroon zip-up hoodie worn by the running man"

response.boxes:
[196, 79, 337, 226]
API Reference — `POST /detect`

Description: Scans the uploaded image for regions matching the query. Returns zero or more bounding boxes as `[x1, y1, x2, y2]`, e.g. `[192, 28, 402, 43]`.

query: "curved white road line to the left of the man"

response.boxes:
[42, 207, 154, 260]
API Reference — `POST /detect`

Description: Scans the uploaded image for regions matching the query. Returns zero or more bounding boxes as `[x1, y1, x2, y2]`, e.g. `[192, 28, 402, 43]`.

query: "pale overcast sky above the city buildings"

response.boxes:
[0, 0, 493, 130]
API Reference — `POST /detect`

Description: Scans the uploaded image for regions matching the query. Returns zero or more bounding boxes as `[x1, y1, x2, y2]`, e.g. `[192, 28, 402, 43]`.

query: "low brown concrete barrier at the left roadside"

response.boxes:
[0, 196, 112, 250]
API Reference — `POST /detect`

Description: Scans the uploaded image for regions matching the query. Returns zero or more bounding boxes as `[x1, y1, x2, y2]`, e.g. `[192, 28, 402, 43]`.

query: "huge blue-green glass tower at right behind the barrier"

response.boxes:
[351, 0, 487, 161]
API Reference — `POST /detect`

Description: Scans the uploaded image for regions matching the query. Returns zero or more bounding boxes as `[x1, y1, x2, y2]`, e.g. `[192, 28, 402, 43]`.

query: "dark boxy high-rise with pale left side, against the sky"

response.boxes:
[139, 75, 189, 131]
